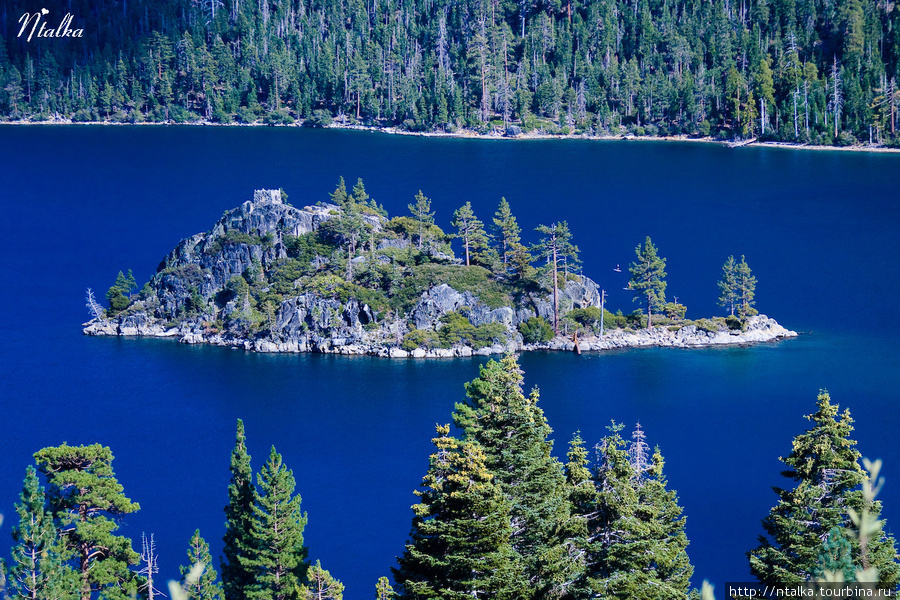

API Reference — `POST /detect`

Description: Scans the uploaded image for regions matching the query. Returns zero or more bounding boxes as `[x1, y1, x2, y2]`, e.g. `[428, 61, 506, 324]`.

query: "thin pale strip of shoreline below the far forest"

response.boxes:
[0, 119, 900, 154]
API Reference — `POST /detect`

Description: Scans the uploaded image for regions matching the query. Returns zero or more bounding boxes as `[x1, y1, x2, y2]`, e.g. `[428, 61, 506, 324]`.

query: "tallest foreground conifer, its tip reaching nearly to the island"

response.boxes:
[453, 356, 575, 596]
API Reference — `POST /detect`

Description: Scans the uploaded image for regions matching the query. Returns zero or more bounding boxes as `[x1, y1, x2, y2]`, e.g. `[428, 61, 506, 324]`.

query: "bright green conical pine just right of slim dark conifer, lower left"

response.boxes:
[240, 446, 309, 600]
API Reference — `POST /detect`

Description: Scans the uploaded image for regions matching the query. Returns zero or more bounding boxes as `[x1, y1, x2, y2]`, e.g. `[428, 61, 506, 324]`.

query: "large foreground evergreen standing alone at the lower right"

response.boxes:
[747, 392, 900, 589]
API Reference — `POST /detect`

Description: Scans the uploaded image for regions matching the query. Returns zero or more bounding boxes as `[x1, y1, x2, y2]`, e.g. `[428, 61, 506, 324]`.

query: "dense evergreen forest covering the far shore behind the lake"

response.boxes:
[0, 0, 900, 145]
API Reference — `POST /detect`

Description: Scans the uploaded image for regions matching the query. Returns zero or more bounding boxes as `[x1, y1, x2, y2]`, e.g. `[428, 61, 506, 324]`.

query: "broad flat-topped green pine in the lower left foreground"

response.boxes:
[34, 444, 140, 600]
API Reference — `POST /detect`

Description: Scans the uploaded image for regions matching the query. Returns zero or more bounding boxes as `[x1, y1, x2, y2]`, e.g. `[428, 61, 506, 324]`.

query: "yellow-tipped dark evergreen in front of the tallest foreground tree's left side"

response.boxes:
[392, 425, 530, 600]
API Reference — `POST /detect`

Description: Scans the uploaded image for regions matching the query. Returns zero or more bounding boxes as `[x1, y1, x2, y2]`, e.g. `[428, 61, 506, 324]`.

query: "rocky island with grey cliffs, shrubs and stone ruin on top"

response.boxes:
[84, 188, 797, 358]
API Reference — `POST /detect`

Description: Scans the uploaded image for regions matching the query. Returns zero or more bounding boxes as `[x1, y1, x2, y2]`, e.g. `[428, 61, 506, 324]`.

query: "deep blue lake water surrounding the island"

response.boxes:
[0, 127, 900, 600]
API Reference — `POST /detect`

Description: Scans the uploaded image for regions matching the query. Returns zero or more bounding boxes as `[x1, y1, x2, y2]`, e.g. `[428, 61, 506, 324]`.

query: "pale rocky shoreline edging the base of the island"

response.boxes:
[84, 315, 798, 358]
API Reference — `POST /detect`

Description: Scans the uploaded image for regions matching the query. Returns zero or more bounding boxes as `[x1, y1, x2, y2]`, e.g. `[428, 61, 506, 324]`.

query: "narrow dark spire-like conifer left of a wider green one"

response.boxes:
[221, 419, 255, 600]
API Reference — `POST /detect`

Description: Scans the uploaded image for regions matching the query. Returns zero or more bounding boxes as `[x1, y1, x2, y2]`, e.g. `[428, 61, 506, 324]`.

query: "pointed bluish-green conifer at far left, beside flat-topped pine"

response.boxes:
[9, 466, 78, 600]
